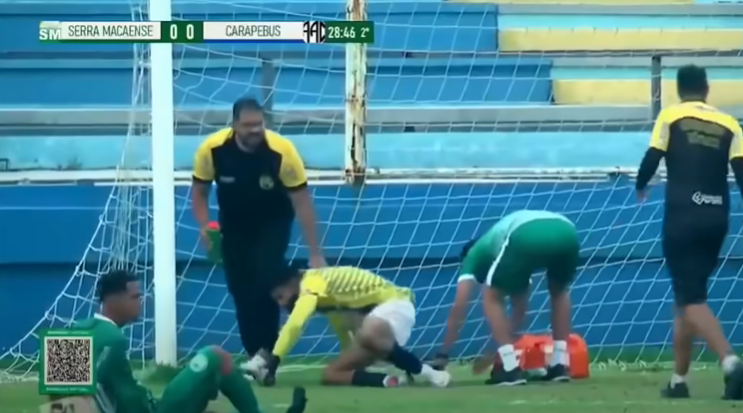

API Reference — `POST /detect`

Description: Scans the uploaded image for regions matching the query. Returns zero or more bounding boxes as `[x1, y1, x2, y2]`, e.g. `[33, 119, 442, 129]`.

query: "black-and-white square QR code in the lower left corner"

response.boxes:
[44, 337, 93, 384]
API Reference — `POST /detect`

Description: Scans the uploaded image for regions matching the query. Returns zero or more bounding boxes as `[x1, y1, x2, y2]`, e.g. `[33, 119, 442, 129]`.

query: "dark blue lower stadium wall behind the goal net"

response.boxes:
[0, 179, 743, 355]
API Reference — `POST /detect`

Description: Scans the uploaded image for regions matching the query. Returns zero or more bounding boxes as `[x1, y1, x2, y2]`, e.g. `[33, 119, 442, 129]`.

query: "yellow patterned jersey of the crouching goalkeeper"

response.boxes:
[273, 267, 413, 357]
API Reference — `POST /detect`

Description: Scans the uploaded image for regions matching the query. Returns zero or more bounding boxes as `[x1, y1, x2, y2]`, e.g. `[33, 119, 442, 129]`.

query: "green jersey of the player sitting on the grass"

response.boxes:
[75, 314, 154, 413]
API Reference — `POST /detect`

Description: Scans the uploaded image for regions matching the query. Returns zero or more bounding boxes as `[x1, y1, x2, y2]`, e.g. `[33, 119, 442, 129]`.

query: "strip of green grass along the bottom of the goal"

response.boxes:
[0, 366, 743, 413]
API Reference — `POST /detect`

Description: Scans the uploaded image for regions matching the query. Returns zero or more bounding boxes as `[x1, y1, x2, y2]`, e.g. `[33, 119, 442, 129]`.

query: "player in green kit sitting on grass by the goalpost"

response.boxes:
[75, 271, 306, 413]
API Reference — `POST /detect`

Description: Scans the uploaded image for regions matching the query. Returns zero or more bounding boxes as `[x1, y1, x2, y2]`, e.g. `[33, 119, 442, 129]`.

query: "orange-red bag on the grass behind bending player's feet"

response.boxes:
[495, 334, 590, 379]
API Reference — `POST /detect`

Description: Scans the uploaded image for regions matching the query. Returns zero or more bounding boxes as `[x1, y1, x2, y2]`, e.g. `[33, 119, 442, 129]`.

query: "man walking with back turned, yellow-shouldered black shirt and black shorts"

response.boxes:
[635, 65, 743, 400]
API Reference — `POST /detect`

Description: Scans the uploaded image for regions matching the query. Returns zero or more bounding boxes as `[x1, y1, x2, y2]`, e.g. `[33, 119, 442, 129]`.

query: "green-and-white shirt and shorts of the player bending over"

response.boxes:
[459, 210, 578, 290]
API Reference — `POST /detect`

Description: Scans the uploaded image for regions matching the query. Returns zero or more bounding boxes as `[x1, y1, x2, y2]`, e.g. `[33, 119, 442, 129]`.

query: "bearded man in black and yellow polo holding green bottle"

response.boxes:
[191, 99, 326, 370]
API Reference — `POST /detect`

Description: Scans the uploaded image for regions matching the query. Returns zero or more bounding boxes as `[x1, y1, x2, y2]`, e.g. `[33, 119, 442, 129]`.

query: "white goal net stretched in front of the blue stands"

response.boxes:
[0, 2, 743, 380]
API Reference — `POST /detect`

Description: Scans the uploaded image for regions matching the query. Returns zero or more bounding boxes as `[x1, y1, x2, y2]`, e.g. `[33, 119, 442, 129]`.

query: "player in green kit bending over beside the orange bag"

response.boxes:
[432, 211, 580, 386]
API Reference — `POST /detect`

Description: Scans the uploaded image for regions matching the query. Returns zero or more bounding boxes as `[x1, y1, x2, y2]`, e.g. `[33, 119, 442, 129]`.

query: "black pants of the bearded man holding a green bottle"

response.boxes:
[222, 224, 291, 356]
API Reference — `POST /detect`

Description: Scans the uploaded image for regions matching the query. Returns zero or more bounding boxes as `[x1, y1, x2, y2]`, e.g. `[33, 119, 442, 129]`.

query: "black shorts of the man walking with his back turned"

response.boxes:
[663, 206, 728, 306]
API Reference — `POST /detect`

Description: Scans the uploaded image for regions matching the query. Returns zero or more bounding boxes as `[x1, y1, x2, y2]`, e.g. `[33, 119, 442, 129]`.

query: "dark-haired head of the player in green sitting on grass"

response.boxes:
[98, 270, 142, 326]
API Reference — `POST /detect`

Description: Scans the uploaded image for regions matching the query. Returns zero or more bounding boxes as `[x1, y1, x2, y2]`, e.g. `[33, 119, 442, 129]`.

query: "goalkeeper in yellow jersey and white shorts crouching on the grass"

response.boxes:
[247, 267, 451, 387]
